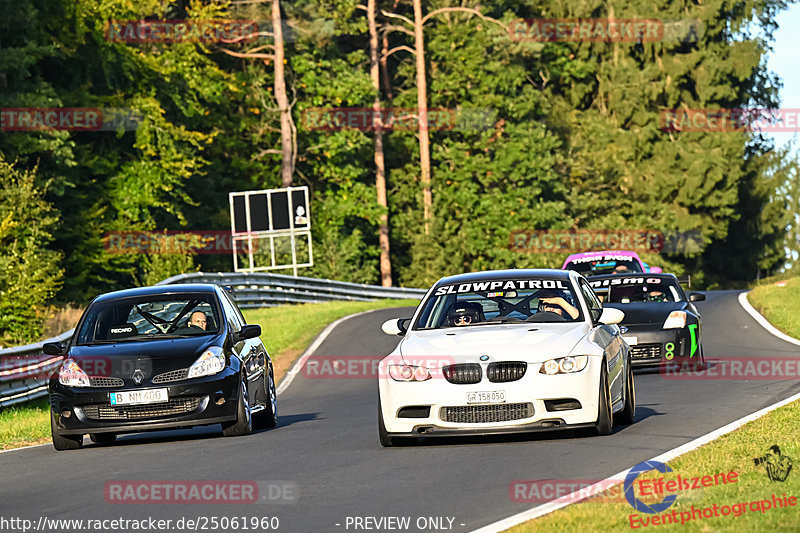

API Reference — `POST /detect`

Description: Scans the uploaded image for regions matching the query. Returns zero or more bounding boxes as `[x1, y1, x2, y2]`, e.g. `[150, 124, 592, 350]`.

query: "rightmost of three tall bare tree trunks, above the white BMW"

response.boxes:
[414, 0, 433, 235]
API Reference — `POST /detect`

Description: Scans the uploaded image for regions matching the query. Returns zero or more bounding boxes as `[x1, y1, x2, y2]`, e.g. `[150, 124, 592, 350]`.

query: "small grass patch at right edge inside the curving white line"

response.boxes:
[747, 277, 800, 339]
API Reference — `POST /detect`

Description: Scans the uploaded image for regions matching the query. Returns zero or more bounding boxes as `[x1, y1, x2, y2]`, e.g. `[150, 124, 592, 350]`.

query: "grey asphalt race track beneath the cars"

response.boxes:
[0, 291, 800, 532]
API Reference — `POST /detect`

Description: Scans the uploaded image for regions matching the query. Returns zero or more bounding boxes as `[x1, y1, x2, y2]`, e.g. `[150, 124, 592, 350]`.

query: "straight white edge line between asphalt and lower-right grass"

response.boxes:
[471, 393, 800, 533]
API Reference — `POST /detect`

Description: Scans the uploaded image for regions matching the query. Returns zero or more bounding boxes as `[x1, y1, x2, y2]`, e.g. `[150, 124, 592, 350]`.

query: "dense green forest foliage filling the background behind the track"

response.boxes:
[0, 0, 800, 341]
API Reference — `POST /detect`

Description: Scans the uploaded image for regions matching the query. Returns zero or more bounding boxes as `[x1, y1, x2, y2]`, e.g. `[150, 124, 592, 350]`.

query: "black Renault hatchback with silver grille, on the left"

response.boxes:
[44, 284, 278, 450]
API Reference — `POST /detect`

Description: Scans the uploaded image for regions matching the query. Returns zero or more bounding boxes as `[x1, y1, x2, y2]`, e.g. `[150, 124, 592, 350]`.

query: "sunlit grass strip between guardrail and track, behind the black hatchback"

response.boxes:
[0, 300, 419, 450]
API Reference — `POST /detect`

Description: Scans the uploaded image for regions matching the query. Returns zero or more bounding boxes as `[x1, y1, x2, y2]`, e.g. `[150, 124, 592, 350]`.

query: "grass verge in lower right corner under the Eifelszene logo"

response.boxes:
[508, 402, 800, 533]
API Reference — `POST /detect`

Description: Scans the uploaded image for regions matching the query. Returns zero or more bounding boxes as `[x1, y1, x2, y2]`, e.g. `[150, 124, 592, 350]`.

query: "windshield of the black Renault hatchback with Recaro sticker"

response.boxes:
[77, 294, 220, 345]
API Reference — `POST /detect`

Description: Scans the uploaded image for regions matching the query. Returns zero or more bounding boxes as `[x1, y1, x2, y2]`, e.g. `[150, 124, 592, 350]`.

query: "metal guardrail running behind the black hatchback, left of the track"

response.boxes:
[0, 272, 426, 408]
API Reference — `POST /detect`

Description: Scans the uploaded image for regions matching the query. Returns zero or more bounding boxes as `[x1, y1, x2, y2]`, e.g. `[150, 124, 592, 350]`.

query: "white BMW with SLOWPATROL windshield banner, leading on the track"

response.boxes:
[378, 270, 636, 446]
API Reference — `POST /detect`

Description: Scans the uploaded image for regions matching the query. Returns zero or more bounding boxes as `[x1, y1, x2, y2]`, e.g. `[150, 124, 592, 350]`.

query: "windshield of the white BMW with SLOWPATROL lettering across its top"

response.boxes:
[414, 278, 582, 329]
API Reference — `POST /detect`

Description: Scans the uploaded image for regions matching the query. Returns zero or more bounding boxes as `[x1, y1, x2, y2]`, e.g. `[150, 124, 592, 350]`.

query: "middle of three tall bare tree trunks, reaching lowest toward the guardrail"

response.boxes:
[367, 0, 392, 287]
